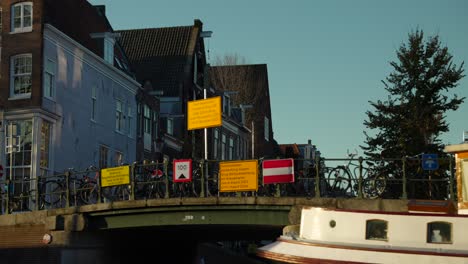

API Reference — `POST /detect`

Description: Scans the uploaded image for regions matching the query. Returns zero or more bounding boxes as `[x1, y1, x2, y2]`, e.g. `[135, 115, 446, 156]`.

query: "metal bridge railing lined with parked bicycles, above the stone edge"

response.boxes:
[0, 157, 456, 214]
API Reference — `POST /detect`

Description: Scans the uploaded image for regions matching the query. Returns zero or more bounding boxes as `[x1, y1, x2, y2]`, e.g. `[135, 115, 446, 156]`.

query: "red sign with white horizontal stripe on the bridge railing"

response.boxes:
[262, 159, 294, 184]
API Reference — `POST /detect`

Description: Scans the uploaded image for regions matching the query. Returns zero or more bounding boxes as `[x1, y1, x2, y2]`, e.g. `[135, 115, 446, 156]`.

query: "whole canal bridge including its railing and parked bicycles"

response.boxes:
[0, 157, 453, 264]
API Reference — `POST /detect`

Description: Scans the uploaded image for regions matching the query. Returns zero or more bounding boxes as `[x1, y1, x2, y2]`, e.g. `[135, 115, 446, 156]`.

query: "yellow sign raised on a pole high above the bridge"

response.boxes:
[187, 96, 222, 130]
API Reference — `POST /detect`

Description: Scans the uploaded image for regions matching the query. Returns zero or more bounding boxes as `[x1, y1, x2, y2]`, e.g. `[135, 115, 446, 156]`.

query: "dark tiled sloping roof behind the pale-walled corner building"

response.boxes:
[117, 20, 201, 96]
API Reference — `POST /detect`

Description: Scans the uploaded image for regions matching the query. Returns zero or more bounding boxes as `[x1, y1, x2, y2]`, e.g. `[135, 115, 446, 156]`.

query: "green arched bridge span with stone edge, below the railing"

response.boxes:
[0, 194, 407, 263]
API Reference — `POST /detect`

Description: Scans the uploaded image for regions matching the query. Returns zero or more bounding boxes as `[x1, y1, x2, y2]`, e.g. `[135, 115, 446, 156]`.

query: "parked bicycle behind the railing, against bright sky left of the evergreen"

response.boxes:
[327, 153, 387, 199]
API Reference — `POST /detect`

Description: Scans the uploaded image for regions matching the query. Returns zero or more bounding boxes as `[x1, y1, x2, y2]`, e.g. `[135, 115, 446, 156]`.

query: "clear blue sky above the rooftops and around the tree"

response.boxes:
[89, 0, 468, 158]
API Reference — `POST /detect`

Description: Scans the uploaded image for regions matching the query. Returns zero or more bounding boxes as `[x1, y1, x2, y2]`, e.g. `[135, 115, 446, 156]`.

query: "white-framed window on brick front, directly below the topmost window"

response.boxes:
[10, 54, 32, 98]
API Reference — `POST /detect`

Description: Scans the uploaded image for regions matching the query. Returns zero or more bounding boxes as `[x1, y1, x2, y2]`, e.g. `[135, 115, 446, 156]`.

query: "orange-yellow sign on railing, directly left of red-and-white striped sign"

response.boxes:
[219, 160, 258, 192]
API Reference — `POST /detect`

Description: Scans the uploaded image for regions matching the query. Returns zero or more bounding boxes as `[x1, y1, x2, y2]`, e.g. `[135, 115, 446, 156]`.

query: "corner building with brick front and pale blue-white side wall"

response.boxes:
[0, 0, 141, 186]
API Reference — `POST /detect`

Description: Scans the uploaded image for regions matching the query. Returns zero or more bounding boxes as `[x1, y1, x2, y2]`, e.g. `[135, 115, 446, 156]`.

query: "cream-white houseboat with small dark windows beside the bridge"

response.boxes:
[257, 144, 468, 264]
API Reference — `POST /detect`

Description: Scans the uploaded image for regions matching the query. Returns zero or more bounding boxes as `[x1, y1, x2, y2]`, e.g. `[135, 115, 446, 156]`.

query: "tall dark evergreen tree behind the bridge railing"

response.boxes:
[361, 30, 465, 198]
